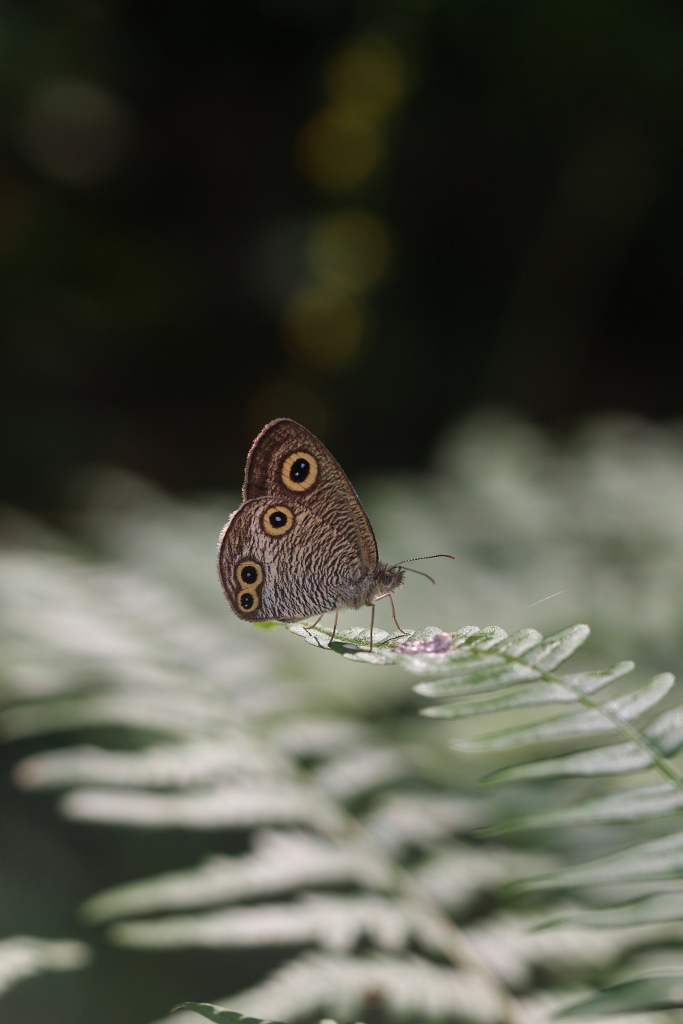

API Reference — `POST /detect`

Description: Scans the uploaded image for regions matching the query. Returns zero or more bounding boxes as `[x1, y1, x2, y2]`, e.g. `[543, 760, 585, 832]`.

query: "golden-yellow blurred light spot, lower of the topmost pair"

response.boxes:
[297, 106, 384, 191]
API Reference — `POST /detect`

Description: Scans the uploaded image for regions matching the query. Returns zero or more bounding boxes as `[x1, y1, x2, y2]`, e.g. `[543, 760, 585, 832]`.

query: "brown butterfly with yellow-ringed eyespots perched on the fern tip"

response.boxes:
[218, 419, 453, 647]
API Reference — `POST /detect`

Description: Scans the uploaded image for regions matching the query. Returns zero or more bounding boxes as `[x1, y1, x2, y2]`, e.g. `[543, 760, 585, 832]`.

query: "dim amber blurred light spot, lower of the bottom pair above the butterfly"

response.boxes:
[283, 288, 364, 371]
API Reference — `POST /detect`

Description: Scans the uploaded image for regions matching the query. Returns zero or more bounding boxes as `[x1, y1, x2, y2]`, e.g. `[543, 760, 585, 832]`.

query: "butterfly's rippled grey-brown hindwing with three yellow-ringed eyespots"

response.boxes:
[218, 493, 368, 622]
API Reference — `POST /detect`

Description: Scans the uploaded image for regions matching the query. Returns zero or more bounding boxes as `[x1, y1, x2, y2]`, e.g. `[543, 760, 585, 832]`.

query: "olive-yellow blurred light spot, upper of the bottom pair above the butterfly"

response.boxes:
[307, 210, 391, 294]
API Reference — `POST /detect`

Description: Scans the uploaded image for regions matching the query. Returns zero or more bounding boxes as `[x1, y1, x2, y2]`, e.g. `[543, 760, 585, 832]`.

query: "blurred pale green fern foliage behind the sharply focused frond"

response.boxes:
[0, 418, 683, 1024]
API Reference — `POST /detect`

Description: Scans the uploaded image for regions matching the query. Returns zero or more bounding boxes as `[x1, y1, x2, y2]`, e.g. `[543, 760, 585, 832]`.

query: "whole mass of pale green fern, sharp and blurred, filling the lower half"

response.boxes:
[0, 411, 683, 1024]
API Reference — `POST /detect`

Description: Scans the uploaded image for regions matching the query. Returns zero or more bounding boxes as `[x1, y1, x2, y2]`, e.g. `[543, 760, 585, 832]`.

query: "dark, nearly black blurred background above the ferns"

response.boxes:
[0, 0, 683, 512]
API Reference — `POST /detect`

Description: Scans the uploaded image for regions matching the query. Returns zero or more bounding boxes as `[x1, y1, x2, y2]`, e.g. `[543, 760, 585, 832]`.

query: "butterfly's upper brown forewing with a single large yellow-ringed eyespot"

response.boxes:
[243, 419, 378, 575]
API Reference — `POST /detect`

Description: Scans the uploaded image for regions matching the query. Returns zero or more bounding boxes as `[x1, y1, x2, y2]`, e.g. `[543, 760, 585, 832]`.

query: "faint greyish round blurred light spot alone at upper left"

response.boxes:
[19, 79, 126, 185]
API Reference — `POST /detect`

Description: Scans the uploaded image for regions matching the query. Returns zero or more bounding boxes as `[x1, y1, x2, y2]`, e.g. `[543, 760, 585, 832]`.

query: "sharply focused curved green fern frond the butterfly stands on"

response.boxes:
[292, 626, 683, 921]
